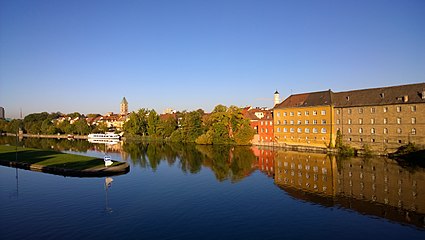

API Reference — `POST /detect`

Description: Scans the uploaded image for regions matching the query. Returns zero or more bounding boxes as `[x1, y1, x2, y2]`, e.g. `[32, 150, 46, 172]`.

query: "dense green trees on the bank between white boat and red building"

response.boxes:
[123, 105, 255, 145]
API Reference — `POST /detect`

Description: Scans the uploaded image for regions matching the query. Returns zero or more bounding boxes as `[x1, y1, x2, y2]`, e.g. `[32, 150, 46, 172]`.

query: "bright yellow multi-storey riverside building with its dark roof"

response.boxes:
[273, 90, 336, 148]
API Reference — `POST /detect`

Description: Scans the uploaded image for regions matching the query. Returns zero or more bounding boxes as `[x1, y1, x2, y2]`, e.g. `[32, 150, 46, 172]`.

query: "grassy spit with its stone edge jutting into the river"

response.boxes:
[0, 145, 130, 177]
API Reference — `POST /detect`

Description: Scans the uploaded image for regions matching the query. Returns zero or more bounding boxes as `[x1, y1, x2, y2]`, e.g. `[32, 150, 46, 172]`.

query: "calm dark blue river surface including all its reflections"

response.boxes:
[0, 137, 425, 239]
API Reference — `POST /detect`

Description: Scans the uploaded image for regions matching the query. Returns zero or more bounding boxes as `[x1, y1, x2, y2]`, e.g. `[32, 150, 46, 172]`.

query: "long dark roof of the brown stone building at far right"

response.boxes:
[334, 83, 425, 107]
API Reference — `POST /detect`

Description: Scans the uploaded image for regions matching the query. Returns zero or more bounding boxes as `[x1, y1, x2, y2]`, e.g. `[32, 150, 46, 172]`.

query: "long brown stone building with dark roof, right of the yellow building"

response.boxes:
[334, 83, 425, 151]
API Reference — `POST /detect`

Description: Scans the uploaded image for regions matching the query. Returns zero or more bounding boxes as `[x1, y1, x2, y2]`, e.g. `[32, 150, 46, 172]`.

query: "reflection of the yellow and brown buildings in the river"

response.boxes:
[274, 150, 425, 228]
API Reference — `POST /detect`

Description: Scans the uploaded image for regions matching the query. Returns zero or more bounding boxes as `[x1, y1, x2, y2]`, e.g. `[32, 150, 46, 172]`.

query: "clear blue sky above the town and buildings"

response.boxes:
[0, 0, 425, 118]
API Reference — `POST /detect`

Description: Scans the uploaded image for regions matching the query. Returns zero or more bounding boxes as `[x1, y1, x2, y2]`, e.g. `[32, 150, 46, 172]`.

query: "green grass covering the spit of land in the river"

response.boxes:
[0, 146, 123, 170]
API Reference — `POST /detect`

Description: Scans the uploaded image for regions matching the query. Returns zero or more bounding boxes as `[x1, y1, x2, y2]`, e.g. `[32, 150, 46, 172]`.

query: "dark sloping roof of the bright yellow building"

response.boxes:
[274, 90, 333, 108]
